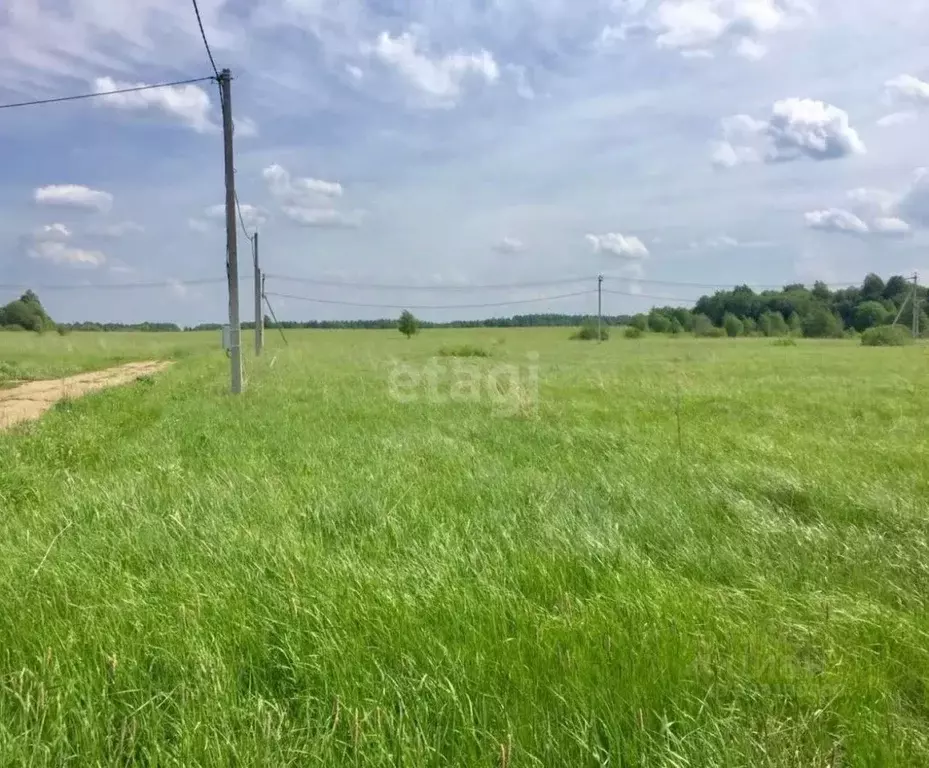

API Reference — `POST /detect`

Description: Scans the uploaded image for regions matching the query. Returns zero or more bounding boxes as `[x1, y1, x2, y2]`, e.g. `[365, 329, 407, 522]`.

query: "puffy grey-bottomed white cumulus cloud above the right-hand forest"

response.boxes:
[710, 98, 867, 168]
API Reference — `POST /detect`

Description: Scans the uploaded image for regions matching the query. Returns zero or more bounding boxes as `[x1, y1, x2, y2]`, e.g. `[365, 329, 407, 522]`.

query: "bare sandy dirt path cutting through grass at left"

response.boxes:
[0, 360, 171, 429]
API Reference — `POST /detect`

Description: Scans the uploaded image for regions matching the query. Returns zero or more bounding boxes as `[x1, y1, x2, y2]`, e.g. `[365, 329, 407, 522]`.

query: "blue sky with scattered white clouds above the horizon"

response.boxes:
[0, 0, 929, 323]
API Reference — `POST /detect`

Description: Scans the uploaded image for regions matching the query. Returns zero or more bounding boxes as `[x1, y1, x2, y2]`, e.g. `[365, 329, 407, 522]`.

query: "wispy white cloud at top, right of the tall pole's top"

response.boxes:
[368, 32, 500, 106]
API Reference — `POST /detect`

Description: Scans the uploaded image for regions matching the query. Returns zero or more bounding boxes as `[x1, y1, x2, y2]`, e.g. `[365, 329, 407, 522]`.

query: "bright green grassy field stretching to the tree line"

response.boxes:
[0, 329, 929, 768]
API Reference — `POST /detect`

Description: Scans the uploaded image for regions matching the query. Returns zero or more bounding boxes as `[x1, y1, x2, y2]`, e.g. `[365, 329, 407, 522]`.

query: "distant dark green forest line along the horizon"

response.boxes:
[0, 274, 929, 338]
